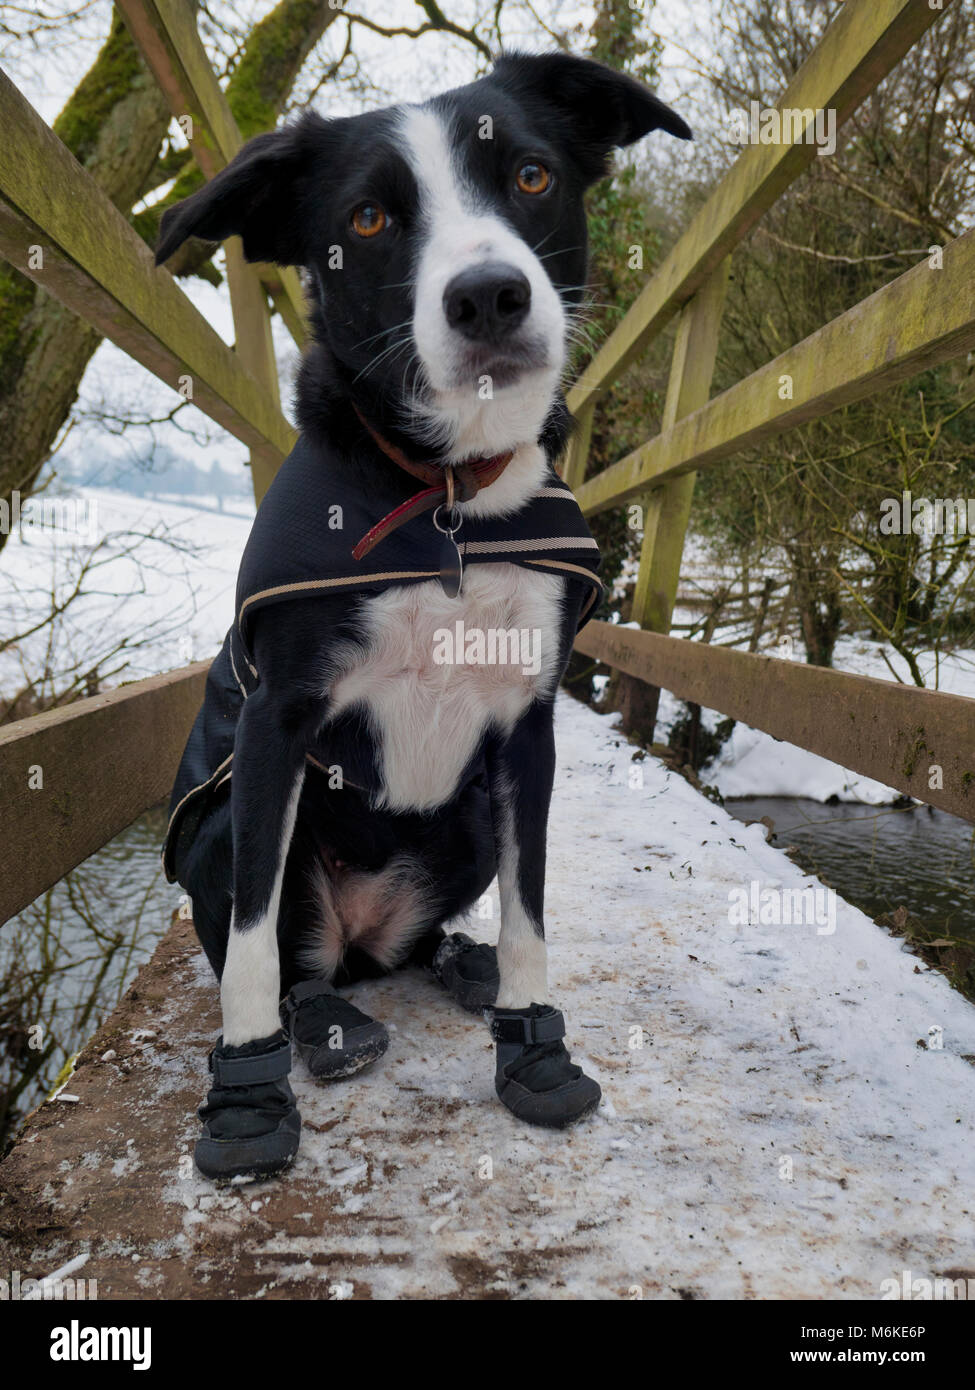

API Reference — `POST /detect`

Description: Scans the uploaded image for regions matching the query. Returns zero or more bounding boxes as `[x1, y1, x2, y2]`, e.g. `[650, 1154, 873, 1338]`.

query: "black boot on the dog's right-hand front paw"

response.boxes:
[491, 1004, 602, 1129]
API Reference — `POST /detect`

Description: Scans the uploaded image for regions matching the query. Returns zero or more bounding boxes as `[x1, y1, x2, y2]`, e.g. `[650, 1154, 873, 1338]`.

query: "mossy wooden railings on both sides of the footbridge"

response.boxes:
[0, 0, 975, 922]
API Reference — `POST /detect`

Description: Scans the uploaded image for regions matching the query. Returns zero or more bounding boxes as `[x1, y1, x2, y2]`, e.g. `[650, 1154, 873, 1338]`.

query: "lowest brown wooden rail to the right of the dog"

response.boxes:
[576, 623, 975, 820]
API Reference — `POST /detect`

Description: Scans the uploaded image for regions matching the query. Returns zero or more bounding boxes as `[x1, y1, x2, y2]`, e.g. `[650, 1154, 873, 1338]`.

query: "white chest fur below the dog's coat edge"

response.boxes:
[330, 564, 565, 810]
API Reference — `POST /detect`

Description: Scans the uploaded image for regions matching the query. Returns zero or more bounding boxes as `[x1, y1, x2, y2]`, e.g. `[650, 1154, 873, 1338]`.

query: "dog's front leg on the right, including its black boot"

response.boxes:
[487, 702, 601, 1129]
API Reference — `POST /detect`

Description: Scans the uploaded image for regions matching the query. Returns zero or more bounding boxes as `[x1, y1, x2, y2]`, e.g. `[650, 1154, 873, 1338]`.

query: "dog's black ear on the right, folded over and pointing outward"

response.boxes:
[494, 53, 691, 177]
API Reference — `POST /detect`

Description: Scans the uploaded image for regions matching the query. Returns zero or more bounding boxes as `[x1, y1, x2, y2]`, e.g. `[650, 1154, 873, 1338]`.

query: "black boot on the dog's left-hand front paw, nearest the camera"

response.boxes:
[196, 1031, 302, 1182]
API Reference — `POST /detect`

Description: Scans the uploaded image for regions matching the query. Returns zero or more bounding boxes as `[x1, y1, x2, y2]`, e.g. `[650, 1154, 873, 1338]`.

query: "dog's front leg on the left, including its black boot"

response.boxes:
[196, 687, 305, 1180]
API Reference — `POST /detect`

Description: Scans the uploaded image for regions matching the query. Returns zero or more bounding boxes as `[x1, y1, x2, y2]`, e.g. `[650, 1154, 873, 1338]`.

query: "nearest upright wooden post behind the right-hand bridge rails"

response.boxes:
[616, 257, 730, 744]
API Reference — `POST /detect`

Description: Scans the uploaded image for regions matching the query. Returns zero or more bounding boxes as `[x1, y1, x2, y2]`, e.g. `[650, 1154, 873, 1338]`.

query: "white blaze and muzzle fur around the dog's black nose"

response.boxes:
[401, 107, 566, 459]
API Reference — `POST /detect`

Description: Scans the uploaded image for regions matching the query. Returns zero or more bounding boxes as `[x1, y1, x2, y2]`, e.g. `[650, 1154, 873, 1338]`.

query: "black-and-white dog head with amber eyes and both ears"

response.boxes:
[156, 53, 690, 460]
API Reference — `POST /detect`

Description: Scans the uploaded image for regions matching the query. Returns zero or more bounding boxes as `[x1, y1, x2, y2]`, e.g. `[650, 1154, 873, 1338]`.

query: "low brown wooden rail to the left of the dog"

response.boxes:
[0, 662, 210, 924]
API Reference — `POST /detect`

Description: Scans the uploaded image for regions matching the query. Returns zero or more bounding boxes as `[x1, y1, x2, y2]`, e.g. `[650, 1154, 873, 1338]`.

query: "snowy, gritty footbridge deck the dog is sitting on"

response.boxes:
[7, 696, 975, 1298]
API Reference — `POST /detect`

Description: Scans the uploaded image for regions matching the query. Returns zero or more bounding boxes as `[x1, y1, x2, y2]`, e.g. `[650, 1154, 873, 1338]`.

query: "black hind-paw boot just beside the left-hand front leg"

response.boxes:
[281, 980, 389, 1081]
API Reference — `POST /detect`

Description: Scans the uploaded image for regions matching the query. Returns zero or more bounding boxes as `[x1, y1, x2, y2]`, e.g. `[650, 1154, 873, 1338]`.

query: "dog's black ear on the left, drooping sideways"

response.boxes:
[156, 113, 322, 265]
